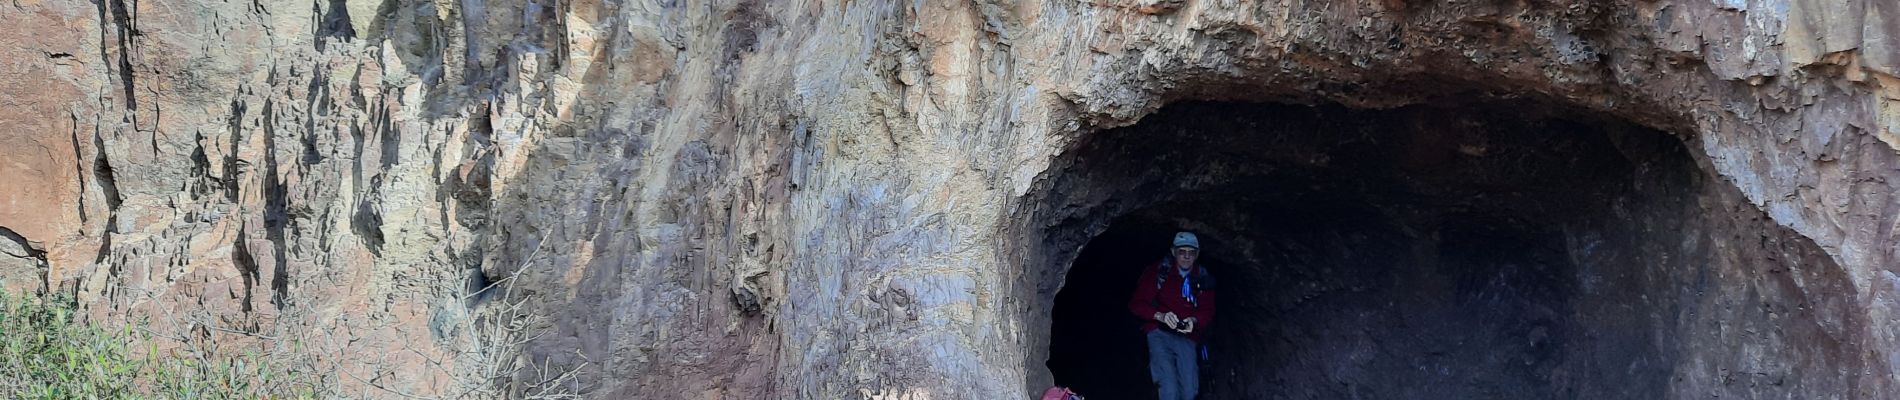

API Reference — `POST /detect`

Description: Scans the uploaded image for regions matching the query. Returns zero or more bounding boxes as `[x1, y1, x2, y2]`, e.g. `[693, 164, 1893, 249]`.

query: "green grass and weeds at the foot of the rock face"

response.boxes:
[0, 292, 319, 400]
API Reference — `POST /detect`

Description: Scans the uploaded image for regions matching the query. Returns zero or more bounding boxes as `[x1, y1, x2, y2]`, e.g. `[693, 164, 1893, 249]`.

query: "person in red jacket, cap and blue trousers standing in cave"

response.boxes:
[1129, 231, 1214, 400]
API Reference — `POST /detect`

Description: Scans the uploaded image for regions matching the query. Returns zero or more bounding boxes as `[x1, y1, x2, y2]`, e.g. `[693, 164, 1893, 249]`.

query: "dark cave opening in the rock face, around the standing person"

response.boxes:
[1037, 99, 1854, 398]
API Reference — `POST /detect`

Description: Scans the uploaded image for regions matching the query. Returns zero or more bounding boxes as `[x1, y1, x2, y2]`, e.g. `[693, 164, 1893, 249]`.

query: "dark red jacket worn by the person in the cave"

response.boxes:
[1129, 260, 1214, 343]
